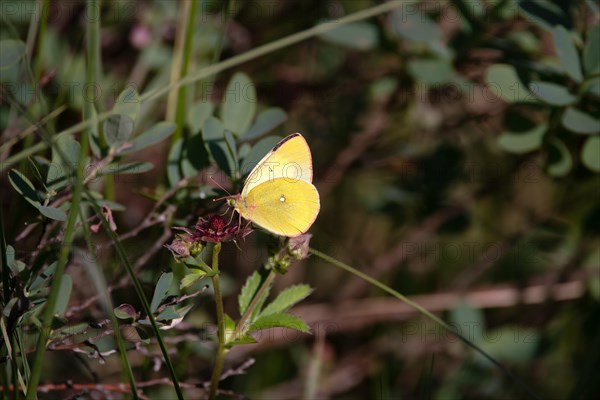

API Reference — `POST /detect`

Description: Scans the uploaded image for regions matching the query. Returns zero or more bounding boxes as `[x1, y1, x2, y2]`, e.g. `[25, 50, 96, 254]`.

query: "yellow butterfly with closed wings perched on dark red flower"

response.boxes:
[230, 133, 320, 237]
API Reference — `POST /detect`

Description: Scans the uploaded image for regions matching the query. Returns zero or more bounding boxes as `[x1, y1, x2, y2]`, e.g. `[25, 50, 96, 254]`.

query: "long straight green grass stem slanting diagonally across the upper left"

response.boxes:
[0, 0, 405, 173]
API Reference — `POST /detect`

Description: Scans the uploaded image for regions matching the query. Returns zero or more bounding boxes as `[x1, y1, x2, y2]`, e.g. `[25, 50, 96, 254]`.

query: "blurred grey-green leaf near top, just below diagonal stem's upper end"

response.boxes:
[392, 7, 442, 43]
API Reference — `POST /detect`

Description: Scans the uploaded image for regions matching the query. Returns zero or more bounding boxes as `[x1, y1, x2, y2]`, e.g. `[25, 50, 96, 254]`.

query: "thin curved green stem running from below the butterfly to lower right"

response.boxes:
[310, 248, 539, 399]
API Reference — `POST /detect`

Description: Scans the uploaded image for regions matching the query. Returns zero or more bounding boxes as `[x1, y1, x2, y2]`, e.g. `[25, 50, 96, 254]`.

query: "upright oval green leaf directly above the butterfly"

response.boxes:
[221, 72, 257, 135]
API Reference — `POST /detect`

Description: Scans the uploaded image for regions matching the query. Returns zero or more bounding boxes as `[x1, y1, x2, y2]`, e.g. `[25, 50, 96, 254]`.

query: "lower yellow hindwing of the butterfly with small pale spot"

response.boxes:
[236, 178, 320, 237]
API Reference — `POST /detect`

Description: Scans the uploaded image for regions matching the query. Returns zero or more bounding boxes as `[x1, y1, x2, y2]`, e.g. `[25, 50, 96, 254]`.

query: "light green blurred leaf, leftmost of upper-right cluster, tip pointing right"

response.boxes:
[485, 64, 536, 103]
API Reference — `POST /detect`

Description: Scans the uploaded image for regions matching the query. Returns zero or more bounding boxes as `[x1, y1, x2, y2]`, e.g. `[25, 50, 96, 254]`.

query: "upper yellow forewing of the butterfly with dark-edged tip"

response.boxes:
[242, 133, 312, 197]
